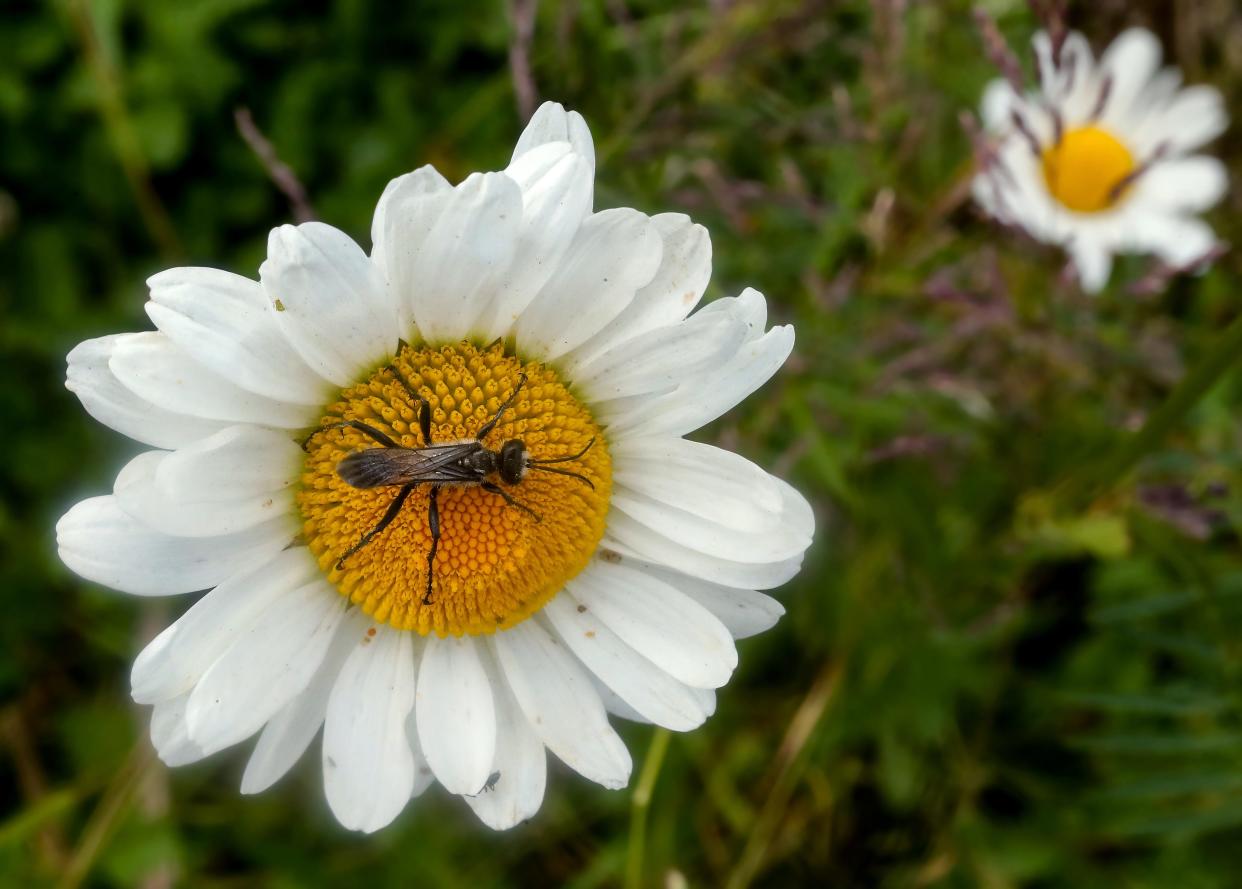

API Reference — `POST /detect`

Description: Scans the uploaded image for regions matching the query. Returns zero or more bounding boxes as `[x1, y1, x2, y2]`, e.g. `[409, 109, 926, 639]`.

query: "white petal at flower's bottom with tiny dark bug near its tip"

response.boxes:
[465, 649, 548, 831]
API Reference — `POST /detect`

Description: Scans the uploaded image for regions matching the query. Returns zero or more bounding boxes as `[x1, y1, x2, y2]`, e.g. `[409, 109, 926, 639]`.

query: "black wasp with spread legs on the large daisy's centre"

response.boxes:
[303, 365, 595, 605]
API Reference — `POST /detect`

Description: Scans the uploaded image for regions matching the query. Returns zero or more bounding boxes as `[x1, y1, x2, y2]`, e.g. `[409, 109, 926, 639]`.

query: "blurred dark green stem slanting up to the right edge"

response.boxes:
[1067, 313, 1242, 507]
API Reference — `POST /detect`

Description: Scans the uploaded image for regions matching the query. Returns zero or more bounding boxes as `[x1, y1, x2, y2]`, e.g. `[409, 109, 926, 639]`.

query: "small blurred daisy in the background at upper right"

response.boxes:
[974, 29, 1228, 292]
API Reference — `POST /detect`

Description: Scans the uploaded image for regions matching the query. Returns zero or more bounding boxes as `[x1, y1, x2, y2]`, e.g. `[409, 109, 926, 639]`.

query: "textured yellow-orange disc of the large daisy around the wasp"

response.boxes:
[298, 343, 612, 636]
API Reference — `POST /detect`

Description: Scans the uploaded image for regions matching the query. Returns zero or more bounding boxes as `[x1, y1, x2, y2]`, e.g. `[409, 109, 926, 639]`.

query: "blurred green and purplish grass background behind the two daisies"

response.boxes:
[0, 0, 1242, 889]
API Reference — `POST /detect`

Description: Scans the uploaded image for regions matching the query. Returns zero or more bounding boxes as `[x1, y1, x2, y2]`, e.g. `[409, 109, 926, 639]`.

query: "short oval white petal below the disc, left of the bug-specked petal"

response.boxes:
[415, 637, 494, 793]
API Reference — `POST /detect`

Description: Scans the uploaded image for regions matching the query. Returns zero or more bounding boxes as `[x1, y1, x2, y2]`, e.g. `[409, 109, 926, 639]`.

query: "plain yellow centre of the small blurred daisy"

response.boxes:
[1043, 127, 1135, 214]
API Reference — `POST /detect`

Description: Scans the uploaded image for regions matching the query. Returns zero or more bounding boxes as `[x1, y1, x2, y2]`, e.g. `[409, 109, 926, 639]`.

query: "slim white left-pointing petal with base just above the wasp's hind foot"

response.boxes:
[108, 333, 319, 428]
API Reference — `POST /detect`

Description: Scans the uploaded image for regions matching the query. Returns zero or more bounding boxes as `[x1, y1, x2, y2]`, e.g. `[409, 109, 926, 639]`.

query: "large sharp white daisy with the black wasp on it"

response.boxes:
[57, 103, 814, 831]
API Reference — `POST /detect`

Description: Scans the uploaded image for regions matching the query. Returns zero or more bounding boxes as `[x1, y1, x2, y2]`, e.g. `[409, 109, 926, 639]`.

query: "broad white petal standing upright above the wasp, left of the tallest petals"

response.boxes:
[407, 173, 522, 344]
